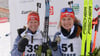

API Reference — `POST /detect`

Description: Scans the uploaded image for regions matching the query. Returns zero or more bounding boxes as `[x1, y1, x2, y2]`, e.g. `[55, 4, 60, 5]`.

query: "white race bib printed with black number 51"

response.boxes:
[60, 34, 81, 56]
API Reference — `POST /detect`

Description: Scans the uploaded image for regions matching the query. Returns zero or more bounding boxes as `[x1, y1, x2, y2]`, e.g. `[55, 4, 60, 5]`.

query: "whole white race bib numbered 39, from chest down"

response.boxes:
[25, 32, 42, 56]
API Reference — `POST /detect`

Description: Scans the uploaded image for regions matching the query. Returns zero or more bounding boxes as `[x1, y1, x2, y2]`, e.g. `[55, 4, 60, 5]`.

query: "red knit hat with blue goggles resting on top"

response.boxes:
[60, 8, 75, 21]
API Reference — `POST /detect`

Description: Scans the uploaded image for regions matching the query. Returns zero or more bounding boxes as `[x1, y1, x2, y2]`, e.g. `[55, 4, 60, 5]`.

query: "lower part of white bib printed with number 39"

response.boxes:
[25, 40, 42, 56]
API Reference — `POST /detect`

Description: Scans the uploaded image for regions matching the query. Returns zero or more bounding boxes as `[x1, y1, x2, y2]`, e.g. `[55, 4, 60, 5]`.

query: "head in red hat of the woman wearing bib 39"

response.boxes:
[27, 11, 40, 33]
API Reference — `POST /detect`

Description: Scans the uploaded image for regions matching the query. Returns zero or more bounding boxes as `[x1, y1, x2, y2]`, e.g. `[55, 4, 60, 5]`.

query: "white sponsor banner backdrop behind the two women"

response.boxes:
[9, 0, 100, 47]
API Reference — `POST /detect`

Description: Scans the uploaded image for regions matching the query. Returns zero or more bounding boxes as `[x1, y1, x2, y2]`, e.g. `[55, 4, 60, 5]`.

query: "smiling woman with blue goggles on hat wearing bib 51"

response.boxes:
[52, 8, 82, 56]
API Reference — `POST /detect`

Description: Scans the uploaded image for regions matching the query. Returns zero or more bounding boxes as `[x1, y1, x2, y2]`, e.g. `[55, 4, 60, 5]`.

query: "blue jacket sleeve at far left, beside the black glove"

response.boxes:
[11, 36, 22, 56]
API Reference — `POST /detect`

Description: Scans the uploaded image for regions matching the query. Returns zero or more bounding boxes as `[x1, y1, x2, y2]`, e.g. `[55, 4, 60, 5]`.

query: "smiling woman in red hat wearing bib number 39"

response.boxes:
[11, 11, 42, 56]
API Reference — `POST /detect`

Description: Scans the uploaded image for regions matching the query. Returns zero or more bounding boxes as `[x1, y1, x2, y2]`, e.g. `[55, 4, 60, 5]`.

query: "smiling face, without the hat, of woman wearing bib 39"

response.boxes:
[27, 19, 39, 32]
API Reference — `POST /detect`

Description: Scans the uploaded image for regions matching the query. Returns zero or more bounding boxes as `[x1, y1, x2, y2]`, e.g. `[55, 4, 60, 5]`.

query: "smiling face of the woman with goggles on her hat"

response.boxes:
[60, 17, 74, 31]
